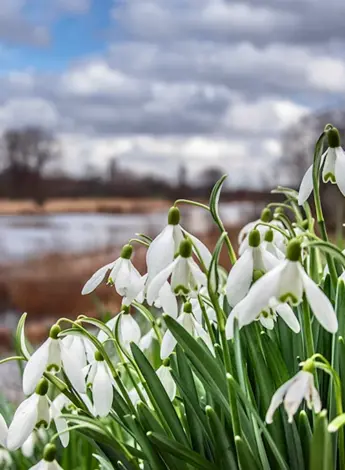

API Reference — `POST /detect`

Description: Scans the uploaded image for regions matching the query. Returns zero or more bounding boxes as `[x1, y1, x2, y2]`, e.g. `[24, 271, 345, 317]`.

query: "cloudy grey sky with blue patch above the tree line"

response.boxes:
[0, 0, 345, 185]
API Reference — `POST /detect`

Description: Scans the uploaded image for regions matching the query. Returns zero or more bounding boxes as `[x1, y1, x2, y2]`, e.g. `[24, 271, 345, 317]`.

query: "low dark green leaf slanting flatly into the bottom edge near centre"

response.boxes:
[147, 432, 219, 470]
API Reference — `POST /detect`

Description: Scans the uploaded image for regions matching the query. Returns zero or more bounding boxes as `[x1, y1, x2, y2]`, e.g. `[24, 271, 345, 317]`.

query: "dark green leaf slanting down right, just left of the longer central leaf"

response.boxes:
[131, 343, 186, 442]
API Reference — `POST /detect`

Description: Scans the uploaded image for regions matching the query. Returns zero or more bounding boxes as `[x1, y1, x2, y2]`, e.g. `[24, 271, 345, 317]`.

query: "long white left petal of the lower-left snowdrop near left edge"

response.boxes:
[7, 394, 39, 450]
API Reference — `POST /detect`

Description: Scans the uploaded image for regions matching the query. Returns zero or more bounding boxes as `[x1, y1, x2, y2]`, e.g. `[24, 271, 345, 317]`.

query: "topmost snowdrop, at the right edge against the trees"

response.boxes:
[298, 127, 345, 205]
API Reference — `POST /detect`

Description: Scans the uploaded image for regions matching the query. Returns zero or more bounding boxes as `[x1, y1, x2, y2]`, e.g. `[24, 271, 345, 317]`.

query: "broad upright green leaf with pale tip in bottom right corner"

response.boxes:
[309, 410, 334, 470]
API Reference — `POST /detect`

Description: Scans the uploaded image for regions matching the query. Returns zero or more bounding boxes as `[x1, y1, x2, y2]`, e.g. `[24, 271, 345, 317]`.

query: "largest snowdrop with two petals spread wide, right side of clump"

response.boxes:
[236, 240, 338, 333]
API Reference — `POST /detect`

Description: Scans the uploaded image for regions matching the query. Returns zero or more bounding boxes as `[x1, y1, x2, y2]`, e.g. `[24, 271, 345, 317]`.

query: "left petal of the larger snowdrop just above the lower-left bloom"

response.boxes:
[23, 338, 52, 395]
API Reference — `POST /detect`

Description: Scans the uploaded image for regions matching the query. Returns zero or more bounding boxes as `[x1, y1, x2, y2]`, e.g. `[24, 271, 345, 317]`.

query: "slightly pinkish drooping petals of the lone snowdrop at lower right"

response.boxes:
[266, 370, 321, 424]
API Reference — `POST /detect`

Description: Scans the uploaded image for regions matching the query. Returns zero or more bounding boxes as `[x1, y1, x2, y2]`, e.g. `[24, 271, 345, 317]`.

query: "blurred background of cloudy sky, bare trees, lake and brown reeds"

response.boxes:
[0, 0, 345, 364]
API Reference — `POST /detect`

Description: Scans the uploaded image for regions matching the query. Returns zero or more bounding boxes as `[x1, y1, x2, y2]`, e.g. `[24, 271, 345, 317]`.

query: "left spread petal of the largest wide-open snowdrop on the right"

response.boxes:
[238, 261, 286, 326]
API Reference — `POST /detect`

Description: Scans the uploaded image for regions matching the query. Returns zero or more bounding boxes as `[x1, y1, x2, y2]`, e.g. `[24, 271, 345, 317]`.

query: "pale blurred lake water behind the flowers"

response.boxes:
[0, 202, 253, 263]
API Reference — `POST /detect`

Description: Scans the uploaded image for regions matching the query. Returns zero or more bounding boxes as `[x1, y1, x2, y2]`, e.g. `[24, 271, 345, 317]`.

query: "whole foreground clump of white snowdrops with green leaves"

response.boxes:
[0, 125, 345, 470]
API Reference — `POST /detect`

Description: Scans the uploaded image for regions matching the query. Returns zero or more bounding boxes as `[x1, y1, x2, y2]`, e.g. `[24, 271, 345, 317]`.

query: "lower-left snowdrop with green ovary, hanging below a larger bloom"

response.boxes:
[7, 379, 50, 450]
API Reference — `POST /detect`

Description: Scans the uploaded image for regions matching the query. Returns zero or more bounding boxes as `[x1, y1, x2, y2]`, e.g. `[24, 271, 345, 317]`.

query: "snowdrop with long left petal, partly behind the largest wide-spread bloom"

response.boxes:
[226, 229, 279, 307]
